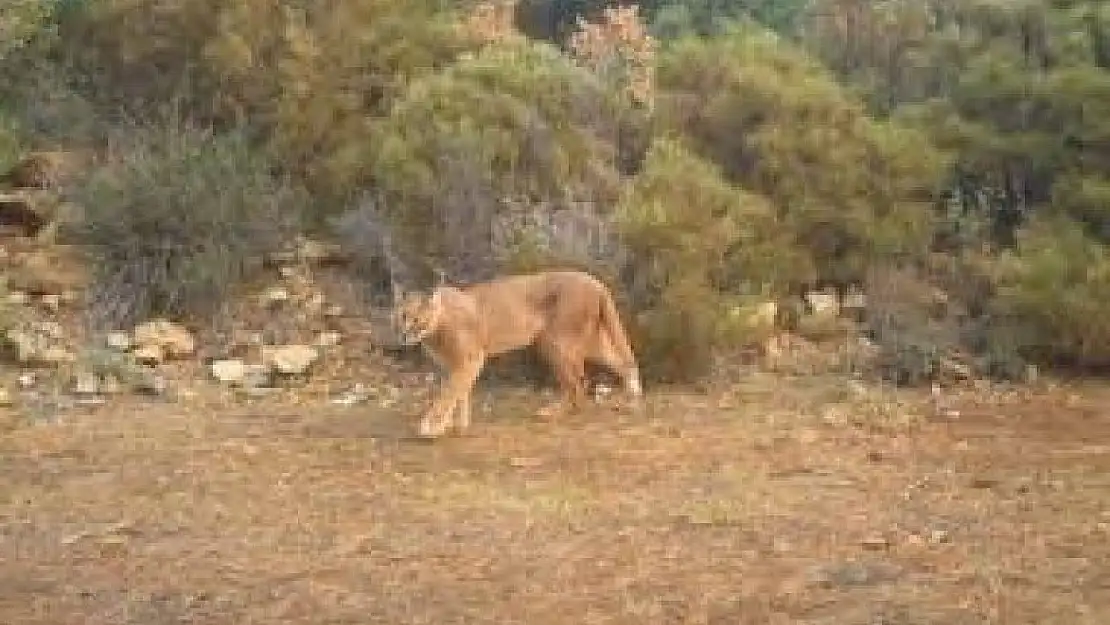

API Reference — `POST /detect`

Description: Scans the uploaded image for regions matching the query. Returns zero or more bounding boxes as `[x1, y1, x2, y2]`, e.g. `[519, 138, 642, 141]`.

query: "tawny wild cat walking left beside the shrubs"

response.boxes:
[394, 271, 643, 436]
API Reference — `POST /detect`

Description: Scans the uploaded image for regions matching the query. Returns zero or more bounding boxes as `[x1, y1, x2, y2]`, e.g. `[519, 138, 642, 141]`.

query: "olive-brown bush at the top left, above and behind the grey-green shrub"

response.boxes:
[52, 0, 468, 204]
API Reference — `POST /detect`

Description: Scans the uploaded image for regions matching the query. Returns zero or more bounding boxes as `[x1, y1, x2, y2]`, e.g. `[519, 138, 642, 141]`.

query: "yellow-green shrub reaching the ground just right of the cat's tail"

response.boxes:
[616, 139, 809, 380]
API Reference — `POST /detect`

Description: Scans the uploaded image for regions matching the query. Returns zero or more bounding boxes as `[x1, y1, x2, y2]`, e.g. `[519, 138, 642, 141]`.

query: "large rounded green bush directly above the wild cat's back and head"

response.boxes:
[361, 41, 622, 279]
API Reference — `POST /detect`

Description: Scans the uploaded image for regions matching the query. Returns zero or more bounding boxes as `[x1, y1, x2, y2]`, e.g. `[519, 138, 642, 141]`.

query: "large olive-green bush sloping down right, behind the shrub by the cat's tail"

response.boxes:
[658, 22, 946, 293]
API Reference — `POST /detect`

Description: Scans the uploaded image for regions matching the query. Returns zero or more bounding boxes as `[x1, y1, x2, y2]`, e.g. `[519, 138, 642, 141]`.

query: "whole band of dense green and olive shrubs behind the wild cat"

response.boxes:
[0, 0, 1110, 381]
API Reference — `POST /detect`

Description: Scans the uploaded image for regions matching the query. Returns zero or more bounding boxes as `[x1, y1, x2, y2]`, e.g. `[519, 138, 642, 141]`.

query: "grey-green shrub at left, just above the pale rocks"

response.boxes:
[68, 121, 304, 326]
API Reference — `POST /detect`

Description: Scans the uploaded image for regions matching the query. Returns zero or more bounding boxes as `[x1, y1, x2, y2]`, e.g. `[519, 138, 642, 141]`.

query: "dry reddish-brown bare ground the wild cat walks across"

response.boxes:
[0, 377, 1110, 625]
